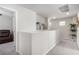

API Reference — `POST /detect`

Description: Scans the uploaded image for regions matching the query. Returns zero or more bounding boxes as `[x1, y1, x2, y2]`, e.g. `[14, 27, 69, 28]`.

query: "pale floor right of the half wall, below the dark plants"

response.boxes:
[47, 40, 79, 55]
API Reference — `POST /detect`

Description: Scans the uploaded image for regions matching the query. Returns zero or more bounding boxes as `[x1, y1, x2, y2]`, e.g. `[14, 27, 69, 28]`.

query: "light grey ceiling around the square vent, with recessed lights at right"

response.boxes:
[19, 4, 79, 18]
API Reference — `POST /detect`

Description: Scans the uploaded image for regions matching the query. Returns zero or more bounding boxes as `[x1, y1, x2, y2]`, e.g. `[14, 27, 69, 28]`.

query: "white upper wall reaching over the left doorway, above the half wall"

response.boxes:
[0, 4, 36, 32]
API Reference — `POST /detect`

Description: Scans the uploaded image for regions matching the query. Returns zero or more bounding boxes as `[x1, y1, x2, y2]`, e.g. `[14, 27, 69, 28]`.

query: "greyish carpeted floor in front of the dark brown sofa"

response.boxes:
[0, 42, 17, 55]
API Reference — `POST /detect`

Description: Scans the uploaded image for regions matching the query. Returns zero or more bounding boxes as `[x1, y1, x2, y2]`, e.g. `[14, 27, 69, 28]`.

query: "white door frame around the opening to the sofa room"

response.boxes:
[0, 5, 17, 51]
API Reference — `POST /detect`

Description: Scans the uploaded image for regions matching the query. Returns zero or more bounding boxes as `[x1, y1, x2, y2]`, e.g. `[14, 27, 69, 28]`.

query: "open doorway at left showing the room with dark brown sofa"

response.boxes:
[0, 7, 17, 55]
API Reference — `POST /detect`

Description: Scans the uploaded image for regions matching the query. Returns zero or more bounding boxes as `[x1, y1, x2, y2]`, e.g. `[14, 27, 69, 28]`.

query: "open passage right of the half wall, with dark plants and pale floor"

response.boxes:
[48, 15, 79, 55]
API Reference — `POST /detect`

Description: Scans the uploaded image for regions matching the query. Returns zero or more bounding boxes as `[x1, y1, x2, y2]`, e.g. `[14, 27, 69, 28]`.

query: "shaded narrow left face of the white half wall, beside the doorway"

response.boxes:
[18, 32, 32, 55]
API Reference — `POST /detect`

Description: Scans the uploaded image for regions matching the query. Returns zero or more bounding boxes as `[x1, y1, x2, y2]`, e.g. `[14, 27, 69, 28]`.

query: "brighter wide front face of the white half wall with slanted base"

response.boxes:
[31, 30, 58, 55]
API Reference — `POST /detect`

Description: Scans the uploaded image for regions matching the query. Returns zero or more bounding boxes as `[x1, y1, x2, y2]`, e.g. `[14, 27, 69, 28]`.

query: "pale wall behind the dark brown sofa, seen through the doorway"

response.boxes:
[0, 15, 13, 31]
